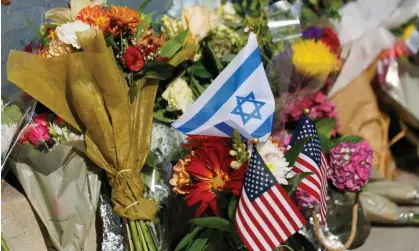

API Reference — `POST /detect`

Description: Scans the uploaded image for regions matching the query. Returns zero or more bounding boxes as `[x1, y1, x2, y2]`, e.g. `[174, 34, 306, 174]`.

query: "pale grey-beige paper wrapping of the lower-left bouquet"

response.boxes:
[7, 141, 101, 251]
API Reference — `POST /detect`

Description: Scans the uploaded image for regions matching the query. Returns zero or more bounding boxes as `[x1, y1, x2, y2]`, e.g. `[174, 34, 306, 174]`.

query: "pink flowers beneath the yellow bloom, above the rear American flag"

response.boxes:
[285, 91, 339, 133]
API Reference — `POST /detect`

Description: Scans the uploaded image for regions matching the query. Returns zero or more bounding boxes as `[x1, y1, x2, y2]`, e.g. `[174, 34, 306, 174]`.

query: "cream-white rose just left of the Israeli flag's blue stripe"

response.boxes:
[162, 77, 194, 112]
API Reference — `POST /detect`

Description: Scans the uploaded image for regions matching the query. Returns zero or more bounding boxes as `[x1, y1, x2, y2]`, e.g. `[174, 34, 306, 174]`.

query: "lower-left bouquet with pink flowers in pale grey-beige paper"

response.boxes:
[12, 108, 101, 250]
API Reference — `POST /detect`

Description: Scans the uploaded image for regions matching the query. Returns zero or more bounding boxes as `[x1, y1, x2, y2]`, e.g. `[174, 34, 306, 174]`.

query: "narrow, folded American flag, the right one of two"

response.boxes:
[289, 115, 328, 224]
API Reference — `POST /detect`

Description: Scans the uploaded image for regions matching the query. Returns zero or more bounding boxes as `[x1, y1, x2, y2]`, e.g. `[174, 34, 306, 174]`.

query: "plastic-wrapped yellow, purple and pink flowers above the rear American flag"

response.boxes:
[267, 18, 340, 142]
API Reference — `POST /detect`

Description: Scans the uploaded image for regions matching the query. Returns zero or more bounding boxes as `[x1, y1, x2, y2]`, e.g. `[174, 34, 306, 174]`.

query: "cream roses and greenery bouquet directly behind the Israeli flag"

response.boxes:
[154, 4, 246, 123]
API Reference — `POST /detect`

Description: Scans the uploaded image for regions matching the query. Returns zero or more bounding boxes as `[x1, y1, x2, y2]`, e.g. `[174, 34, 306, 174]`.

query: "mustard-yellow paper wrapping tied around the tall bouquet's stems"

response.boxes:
[7, 29, 158, 220]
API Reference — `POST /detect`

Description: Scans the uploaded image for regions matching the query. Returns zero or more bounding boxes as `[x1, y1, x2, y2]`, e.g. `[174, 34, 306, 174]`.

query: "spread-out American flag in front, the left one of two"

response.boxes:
[236, 147, 306, 251]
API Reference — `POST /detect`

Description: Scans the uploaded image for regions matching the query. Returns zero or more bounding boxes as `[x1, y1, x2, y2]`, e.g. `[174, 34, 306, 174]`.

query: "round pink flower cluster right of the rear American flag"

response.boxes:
[328, 141, 373, 192]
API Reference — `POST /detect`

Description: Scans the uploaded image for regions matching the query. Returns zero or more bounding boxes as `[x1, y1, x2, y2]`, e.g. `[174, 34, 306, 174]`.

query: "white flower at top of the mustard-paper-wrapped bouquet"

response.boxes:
[55, 20, 90, 49]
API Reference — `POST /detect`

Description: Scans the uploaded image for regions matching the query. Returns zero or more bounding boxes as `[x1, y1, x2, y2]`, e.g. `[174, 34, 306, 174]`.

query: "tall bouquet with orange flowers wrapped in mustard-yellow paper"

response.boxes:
[8, 0, 195, 250]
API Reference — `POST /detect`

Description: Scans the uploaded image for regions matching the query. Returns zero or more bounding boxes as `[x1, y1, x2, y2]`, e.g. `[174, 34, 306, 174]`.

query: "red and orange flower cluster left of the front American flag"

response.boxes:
[171, 140, 247, 217]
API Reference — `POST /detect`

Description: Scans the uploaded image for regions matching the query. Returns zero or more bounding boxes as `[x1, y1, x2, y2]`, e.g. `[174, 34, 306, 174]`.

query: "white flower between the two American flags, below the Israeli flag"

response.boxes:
[257, 140, 295, 185]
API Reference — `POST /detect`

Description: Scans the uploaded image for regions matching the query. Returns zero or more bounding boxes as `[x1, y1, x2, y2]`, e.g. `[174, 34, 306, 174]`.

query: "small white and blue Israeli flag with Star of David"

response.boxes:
[172, 33, 275, 141]
